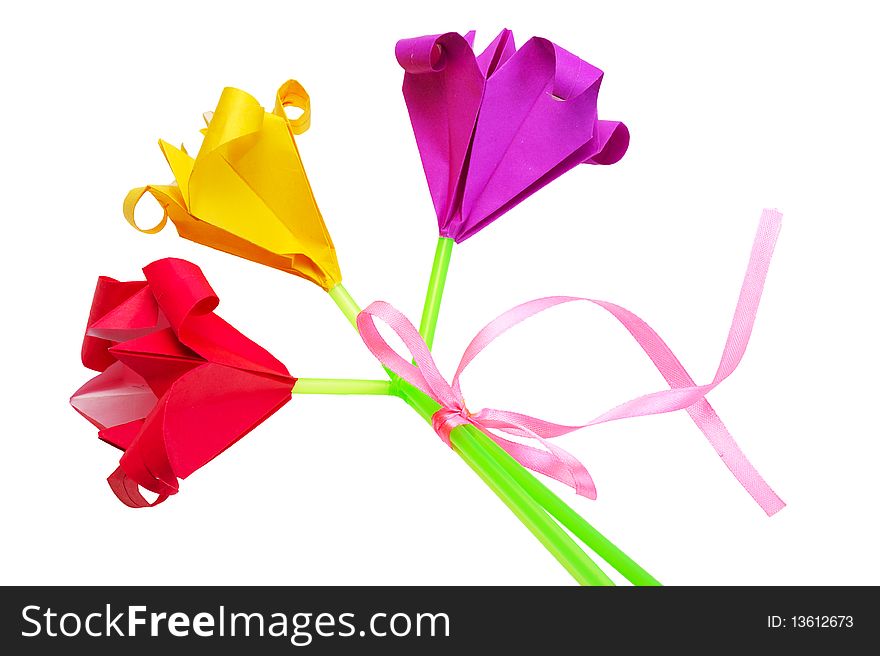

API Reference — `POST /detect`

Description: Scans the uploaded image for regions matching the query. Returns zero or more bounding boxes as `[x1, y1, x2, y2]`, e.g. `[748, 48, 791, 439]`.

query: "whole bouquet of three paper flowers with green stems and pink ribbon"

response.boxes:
[71, 30, 784, 585]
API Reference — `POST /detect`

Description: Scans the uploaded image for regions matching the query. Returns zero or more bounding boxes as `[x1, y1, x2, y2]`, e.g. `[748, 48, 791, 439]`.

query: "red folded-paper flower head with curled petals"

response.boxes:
[70, 258, 296, 508]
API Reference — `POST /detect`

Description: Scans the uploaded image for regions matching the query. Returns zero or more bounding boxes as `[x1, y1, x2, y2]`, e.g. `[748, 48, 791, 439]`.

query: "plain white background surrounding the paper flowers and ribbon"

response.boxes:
[0, 0, 880, 585]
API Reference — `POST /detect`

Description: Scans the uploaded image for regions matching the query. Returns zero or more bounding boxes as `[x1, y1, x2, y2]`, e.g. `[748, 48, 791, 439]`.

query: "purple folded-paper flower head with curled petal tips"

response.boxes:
[395, 30, 629, 242]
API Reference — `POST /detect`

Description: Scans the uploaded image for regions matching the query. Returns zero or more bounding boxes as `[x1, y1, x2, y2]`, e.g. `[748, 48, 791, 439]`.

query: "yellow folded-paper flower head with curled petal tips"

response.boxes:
[123, 80, 342, 290]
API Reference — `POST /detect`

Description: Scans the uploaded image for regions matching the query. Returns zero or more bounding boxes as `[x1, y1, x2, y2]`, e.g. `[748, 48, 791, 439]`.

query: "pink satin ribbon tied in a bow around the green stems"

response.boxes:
[357, 210, 785, 515]
